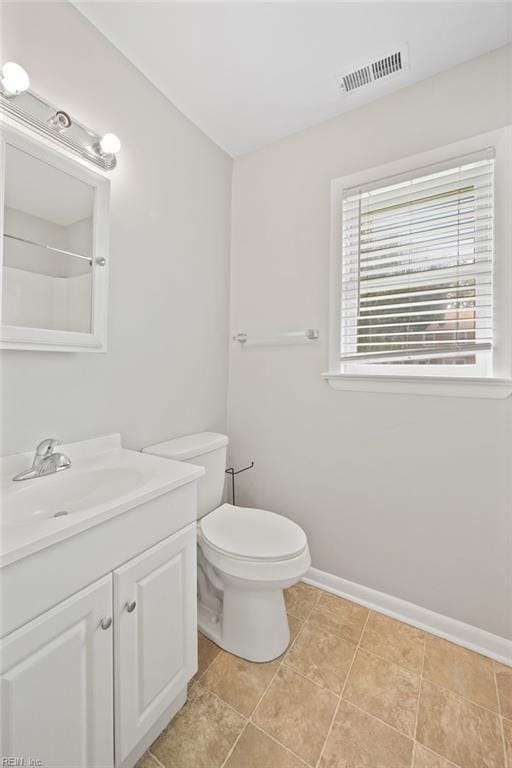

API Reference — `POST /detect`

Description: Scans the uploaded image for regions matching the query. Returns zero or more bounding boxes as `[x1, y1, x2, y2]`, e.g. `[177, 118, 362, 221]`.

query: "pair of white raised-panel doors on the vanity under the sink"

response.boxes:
[0, 523, 197, 768]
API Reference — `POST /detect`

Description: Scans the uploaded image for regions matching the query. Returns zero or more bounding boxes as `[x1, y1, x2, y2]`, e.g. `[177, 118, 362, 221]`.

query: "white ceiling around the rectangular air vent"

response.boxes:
[74, 0, 512, 155]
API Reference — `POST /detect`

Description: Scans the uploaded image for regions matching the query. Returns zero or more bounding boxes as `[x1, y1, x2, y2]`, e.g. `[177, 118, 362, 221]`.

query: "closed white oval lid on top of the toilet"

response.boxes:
[200, 504, 307, 561]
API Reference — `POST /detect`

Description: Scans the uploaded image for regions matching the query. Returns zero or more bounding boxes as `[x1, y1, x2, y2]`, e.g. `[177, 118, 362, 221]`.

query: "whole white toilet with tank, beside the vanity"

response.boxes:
[144, 432, 311, 661]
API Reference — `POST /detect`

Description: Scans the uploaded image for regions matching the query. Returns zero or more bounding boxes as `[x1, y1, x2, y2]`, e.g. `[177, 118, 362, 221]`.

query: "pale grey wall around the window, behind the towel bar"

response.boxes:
[229, 47, 512, 638]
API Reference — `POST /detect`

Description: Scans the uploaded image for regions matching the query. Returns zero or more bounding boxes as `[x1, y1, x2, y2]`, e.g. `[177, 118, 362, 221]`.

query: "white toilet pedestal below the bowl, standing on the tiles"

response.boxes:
[197, 578, 290, 662]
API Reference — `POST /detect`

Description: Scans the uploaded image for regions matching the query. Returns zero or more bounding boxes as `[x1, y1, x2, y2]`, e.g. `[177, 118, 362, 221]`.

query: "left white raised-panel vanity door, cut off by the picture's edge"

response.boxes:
[0, 575, 113, 768]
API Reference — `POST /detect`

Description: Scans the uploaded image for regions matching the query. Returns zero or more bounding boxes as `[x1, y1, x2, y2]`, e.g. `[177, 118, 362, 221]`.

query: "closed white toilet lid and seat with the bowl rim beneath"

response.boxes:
[198, 504, 311, 584]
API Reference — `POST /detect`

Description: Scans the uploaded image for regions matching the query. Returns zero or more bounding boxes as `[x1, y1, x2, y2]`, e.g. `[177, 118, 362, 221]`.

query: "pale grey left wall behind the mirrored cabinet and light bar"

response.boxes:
[0, 2, 232, 453]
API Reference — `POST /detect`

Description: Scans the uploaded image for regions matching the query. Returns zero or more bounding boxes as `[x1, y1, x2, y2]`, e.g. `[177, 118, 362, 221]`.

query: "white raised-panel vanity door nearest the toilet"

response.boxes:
[114, 523, 197, 763]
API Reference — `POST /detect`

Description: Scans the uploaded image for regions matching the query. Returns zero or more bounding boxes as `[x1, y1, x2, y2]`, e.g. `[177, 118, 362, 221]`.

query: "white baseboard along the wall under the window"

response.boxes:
[303, 568, 512, 667]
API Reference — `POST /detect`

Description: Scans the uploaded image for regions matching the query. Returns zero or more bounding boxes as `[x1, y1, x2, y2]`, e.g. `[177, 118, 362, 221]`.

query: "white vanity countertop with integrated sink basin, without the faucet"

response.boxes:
[0, 435, 204, 565]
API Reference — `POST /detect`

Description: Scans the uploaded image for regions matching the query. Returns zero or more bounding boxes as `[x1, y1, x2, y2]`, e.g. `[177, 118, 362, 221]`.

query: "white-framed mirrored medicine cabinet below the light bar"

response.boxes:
[1, 128, 109, 351]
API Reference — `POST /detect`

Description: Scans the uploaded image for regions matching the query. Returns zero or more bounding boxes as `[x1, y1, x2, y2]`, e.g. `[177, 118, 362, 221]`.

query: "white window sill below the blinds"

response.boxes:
[322, 373, 512, 400]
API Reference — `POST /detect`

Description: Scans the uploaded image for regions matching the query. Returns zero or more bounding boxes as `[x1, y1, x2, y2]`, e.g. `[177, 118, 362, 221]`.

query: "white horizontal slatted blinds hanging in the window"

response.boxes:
[341, 150, 494, 365]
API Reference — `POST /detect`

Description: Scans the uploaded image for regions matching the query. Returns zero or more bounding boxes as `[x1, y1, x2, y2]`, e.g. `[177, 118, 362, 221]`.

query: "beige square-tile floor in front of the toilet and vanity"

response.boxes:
[138, 583, 512, 768]
